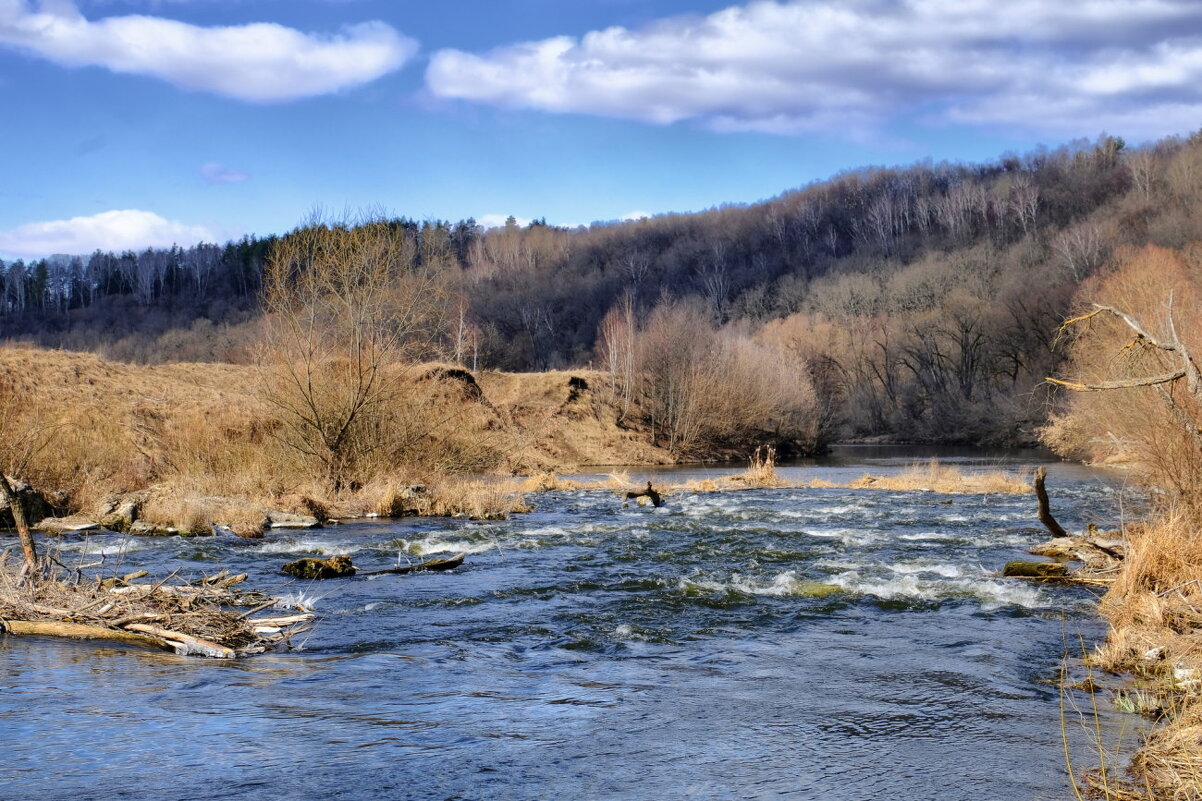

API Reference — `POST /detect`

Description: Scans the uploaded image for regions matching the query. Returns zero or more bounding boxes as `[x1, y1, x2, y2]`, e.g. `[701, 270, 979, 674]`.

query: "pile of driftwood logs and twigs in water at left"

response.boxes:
[0, 554, 314, 659]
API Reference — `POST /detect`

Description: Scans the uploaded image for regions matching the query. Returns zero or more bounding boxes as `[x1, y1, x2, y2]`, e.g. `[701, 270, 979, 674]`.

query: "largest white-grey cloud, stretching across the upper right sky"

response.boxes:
[427, 0, 1202, 135]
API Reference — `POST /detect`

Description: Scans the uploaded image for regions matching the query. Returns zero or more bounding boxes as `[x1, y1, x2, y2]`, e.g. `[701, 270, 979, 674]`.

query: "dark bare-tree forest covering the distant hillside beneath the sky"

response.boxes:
[0, 134, 1202, 444]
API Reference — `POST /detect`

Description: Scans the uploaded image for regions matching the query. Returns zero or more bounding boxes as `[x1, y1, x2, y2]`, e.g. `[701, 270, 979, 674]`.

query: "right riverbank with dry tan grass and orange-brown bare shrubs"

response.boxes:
[1045, 245, 1202, 801]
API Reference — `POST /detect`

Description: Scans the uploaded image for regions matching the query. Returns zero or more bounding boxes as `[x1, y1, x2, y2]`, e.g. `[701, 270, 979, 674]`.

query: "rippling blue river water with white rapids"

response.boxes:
[0, 450, 1139, 801]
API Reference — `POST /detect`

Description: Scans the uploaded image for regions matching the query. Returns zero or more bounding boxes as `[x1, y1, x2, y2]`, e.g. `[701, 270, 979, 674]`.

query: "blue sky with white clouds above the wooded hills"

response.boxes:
[0, 0, 1202, 257]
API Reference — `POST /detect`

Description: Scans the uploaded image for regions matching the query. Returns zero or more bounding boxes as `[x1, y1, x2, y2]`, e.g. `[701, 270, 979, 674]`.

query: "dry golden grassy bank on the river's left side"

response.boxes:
[0, 348, 674, 533]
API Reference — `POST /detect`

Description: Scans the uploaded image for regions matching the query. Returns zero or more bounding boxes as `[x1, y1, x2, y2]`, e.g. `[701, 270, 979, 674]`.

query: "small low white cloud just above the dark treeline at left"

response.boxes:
[0, 209, 218, 257]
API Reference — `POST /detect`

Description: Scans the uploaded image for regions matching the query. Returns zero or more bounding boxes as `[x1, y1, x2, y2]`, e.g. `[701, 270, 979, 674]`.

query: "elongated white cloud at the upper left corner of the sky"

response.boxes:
[0, 0, 417, 102]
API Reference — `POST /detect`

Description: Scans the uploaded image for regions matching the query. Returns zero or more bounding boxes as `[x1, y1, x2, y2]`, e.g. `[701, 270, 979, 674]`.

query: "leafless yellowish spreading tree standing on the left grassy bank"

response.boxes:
[258, 219, 446, 492]
